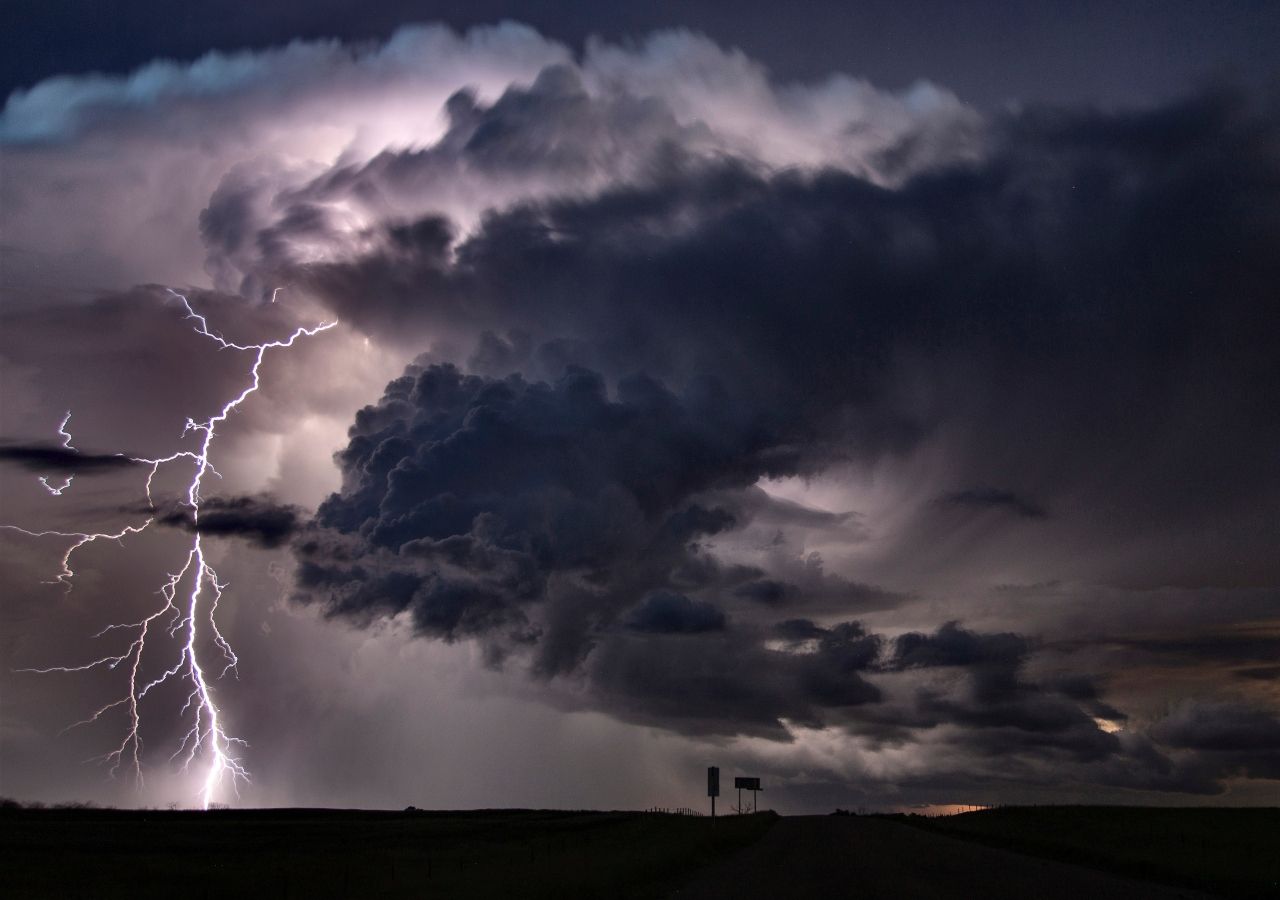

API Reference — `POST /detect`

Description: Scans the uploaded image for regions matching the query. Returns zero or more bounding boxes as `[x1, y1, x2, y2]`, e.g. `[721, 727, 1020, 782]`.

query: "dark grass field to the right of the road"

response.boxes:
[901, 807, 1280, 899]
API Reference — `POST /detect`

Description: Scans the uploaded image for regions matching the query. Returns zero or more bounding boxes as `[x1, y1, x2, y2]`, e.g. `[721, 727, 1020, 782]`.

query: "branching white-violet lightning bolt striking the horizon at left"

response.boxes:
[0, 289, 338, 809]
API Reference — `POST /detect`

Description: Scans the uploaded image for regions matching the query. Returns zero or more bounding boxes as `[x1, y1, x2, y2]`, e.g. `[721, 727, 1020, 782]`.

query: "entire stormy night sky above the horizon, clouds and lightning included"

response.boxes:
[0, 0, 1280, 813]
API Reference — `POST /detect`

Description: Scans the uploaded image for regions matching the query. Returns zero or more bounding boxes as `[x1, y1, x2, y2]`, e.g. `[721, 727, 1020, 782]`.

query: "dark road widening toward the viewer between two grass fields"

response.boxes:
[673, 816, 1207, 900]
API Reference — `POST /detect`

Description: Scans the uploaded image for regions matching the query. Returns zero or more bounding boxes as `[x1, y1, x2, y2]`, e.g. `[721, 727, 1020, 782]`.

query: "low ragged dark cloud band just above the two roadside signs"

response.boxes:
[586, 620, 1136, 757]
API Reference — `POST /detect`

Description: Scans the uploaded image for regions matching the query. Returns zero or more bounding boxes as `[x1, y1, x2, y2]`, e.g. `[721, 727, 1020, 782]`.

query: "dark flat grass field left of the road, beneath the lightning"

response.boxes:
[0, 809, 777, 900]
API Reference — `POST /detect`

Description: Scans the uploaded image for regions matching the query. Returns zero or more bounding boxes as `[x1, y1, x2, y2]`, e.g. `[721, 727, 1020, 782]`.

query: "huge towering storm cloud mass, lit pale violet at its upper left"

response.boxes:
[0, 24, 1280, 796]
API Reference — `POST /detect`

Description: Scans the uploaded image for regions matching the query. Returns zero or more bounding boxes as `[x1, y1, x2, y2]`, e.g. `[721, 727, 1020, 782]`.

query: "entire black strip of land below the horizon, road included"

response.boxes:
[0, 807, 1280, 900]
